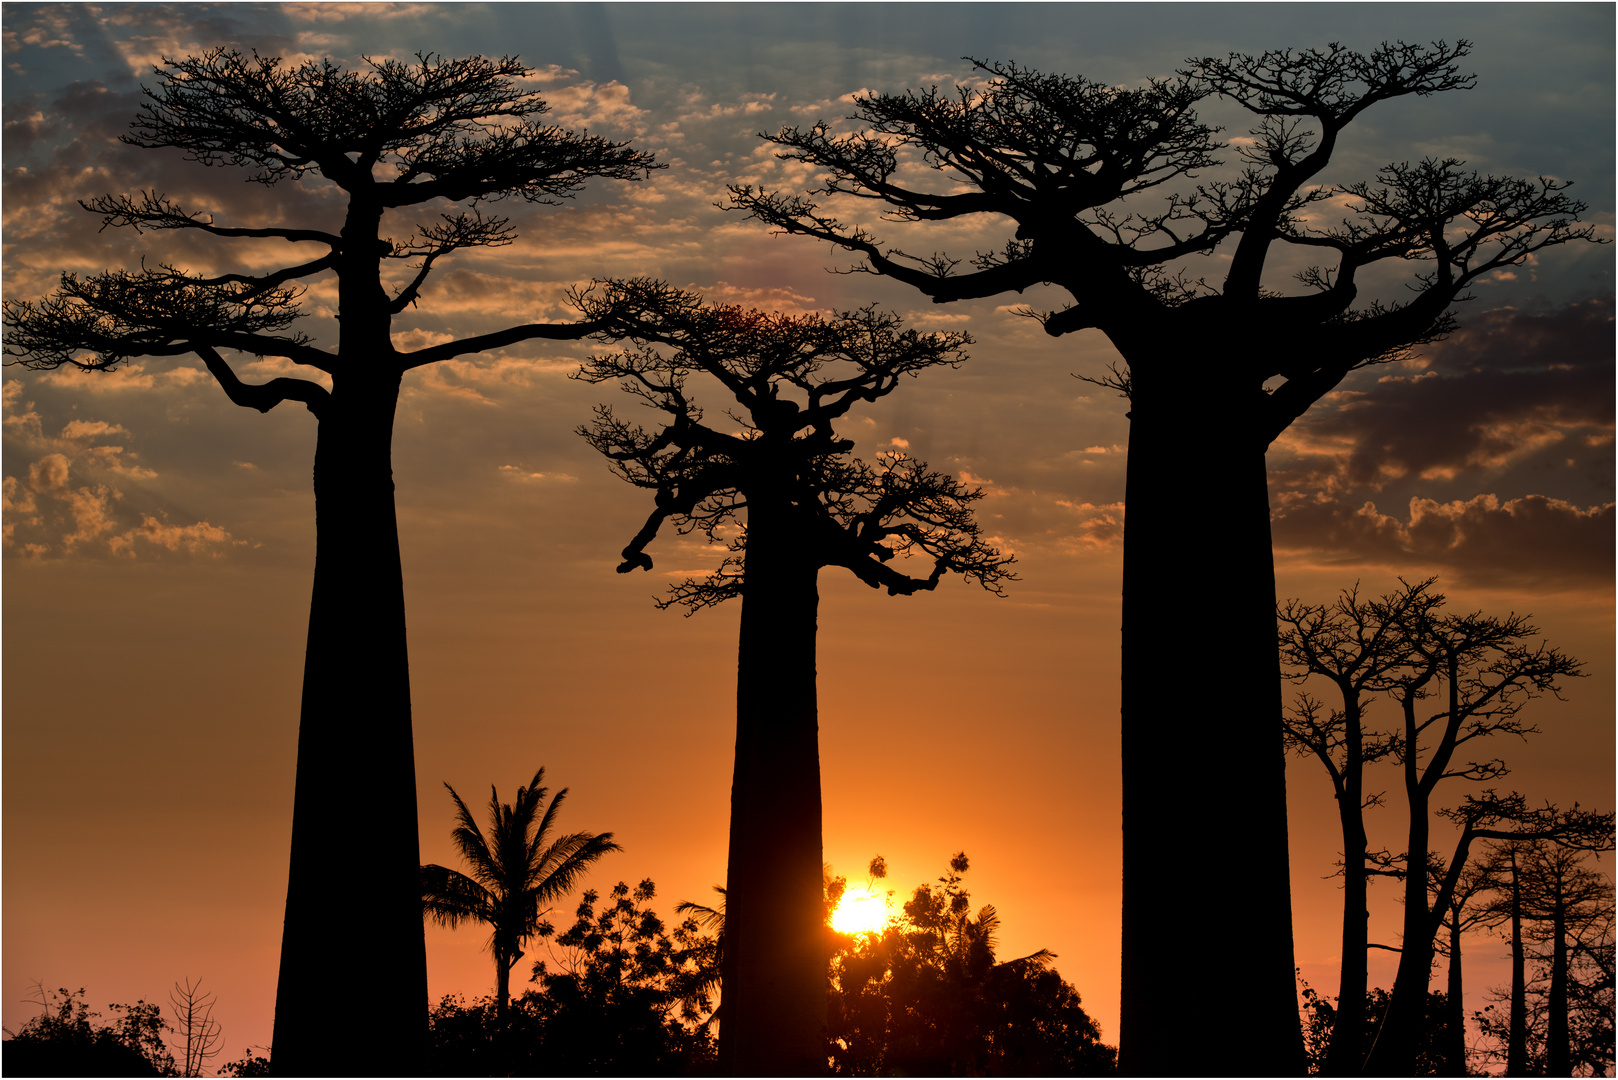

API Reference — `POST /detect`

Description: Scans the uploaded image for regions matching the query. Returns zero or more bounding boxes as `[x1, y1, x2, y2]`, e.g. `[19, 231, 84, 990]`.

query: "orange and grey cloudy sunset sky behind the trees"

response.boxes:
[0, 3, 1615, 1064]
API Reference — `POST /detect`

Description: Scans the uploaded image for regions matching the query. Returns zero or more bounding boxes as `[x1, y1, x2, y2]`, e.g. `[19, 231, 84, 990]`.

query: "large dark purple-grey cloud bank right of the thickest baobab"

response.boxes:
[1272, 296, 1613, 588]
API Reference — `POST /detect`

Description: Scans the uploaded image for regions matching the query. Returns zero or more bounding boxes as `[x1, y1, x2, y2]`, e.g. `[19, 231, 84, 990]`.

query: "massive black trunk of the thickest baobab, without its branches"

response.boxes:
[1118, 369, 1304, 1075]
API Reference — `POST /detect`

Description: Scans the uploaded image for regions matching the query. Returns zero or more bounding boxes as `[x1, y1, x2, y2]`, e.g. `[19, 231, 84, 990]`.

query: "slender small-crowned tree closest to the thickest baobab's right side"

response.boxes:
[1278, 581, 1438, 1077]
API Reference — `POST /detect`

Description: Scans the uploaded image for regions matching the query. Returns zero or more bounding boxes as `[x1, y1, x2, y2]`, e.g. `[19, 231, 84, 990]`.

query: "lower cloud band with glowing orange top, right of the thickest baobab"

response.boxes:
[1272, 494, 1615, 588]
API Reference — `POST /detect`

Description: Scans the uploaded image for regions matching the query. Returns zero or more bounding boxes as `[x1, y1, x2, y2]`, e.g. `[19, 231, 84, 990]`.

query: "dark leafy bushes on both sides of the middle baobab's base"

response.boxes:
[427, 855, 1116, 1077]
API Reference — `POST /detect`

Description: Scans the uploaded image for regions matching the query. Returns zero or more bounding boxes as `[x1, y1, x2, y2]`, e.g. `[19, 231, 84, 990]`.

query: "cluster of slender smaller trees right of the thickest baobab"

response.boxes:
[1278, 578, 1613, 1077]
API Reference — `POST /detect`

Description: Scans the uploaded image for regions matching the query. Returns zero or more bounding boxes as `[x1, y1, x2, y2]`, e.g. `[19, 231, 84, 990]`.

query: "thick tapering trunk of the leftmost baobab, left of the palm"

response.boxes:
[272, 376, 427, 1077]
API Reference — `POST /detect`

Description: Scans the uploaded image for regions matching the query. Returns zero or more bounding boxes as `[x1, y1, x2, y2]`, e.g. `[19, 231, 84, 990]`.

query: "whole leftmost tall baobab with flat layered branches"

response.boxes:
[5, 49, 654, 1075]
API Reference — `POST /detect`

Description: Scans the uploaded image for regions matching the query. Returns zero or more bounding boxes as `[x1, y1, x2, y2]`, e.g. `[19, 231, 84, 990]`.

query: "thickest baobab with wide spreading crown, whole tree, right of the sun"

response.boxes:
[731, 42, 1592, 1075]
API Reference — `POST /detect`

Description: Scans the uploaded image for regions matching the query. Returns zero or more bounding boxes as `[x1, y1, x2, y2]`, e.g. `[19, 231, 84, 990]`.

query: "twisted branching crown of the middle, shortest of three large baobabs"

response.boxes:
[579, 293, 1011, 610]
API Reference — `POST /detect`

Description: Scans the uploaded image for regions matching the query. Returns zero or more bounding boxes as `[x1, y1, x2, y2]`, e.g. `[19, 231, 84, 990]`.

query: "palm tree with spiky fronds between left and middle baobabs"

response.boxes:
[421, 766, 623, 1025]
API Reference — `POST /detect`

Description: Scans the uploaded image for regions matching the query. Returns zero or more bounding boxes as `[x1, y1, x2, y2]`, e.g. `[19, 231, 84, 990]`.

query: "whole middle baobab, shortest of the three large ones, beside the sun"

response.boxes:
[579, 291, 1010, 1075]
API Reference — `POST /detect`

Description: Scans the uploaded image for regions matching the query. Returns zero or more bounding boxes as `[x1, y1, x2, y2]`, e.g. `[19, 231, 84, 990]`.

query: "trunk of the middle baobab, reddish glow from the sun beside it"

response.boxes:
[718, 500, 827, 1077]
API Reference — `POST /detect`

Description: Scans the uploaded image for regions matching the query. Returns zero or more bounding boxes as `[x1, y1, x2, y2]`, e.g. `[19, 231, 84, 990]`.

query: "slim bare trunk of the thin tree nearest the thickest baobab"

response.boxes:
[1322, 705, 1370, 1077]
